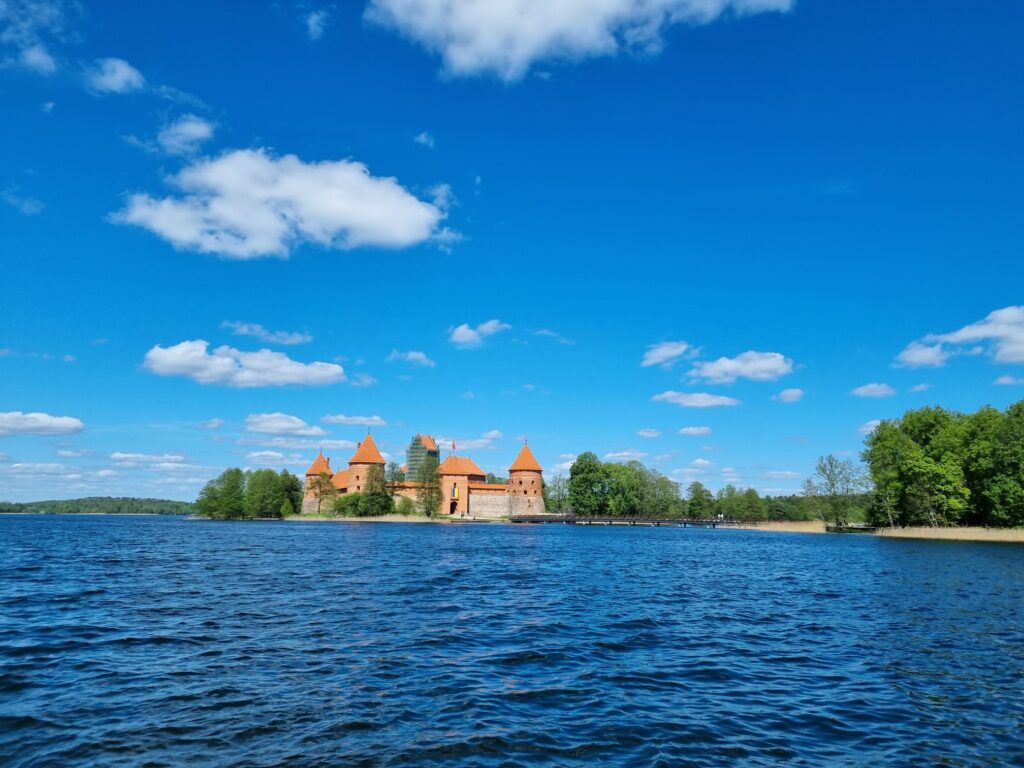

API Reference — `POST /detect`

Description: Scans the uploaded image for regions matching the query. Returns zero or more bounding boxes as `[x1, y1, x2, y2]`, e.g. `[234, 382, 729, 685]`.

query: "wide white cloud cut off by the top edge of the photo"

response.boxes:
[367, 0, 794, 81]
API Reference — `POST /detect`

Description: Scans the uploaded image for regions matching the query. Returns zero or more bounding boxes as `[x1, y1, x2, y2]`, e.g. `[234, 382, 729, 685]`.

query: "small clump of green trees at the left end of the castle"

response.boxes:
[196, 467, 302, 520]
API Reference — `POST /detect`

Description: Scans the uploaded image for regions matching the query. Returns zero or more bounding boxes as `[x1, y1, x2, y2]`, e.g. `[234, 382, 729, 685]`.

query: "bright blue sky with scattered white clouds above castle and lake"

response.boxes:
[0, 0, 1024, 500]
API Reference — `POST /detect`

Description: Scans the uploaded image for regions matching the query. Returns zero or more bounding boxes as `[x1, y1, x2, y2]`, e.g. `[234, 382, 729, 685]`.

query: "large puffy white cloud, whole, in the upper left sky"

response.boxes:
[112, 150, 458, 259]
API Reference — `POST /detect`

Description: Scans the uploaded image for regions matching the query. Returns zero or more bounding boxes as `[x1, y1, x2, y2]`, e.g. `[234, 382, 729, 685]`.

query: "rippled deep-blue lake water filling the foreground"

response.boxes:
[0, 516, 1024, 766]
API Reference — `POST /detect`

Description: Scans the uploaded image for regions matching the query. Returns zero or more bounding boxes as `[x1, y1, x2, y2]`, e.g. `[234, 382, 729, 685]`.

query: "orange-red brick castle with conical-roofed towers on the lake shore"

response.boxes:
[302, 434, 544, 517]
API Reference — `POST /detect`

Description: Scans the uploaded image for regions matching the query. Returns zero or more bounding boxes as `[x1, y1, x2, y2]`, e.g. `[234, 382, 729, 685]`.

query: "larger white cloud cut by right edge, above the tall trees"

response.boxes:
[896, 305, 1024, 368]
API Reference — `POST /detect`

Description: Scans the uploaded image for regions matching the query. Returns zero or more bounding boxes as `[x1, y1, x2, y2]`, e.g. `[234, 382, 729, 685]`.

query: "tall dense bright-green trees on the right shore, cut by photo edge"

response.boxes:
[862, 400, 1024, 527]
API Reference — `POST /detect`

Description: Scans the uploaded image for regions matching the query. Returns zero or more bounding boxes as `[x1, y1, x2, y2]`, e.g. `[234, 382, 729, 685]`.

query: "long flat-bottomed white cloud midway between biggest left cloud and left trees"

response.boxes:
[142, 339, 345, 388]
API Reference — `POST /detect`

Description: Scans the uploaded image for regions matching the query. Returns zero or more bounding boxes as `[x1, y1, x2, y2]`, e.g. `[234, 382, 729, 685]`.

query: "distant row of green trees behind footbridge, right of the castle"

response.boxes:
[544, 452, 831, 521]
